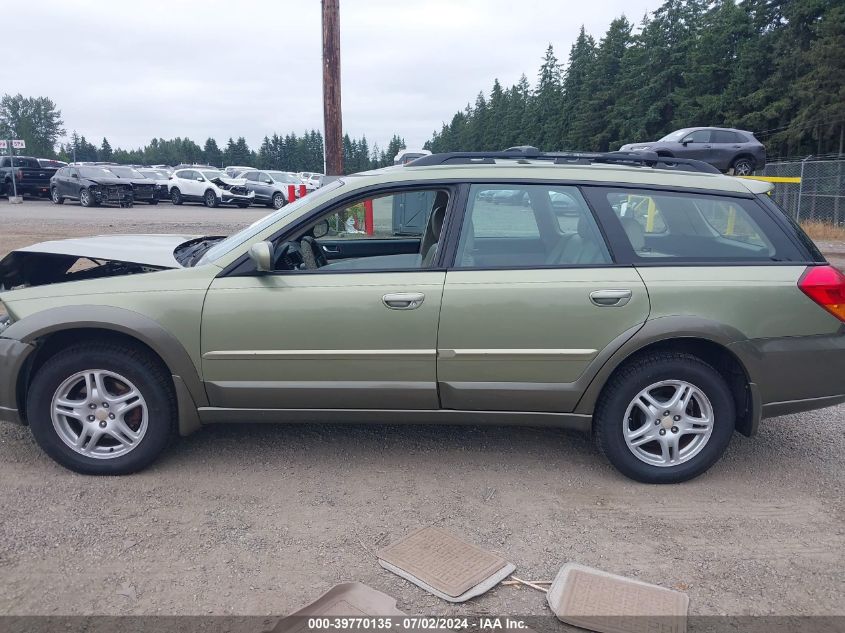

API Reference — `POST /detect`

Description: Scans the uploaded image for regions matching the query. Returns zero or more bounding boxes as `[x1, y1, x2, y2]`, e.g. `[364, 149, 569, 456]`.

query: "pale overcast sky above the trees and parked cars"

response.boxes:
[8, 0, 661, 148]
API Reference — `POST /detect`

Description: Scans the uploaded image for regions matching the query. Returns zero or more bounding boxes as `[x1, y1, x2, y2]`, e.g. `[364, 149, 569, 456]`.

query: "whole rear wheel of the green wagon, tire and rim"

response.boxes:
[594, 353, 736, 484]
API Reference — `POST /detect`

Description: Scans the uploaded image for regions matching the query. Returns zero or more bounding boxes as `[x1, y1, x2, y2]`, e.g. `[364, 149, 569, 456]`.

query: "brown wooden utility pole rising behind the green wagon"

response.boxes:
[322, 0, 343, 176]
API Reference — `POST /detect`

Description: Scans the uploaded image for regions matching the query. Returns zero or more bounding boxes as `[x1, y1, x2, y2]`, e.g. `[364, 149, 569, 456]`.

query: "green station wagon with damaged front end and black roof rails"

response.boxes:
[0, 148, 845, 483]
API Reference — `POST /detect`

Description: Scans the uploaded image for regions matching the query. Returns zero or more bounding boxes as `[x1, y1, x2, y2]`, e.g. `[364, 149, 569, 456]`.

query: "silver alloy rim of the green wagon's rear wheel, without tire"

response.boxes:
[622, 380, 714, 467]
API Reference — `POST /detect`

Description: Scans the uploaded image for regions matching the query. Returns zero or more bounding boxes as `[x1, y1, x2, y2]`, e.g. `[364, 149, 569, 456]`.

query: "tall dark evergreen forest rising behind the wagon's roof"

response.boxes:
[425, 0, 845, 158]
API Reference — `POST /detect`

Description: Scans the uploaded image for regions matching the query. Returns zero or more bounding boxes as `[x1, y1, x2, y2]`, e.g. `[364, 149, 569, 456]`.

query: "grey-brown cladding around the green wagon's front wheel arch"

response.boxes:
[3, 305, 208, 434]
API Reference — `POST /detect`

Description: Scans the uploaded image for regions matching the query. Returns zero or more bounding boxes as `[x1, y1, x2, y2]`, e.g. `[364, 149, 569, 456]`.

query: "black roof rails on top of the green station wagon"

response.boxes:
[405, 145, 721, 174]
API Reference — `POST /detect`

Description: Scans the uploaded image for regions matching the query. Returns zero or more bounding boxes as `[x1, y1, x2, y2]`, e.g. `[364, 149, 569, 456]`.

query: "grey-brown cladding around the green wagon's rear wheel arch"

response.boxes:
[575, 316, 762, 436]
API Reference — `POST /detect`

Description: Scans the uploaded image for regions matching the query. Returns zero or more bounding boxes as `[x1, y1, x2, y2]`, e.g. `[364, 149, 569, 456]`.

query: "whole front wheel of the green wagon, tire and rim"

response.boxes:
[27, 343, 176, 475]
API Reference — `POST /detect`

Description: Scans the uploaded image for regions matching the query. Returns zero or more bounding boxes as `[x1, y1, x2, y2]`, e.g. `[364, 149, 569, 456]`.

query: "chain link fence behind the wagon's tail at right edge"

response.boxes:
[760, 157, 845, 226]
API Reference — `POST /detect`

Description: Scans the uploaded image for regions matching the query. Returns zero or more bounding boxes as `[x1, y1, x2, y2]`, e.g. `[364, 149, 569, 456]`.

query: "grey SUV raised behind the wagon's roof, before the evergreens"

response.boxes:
[620, 127, 766, 176]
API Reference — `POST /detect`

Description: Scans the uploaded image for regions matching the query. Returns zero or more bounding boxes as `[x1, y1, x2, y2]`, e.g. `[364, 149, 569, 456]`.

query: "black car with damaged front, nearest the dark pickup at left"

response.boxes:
[50, 165, 134, 207]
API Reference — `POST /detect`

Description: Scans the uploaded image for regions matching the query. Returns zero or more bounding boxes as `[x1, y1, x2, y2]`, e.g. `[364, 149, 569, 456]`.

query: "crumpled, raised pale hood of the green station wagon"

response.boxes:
[0, 235, 197, 290]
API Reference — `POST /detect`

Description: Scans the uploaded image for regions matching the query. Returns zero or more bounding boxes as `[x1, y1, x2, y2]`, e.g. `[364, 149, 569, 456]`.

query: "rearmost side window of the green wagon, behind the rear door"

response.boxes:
[587, 187, 806, 263]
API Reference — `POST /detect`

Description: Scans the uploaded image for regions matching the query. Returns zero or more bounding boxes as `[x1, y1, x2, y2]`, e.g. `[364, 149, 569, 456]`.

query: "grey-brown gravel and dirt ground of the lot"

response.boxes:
[0, 201, 845, 615]
